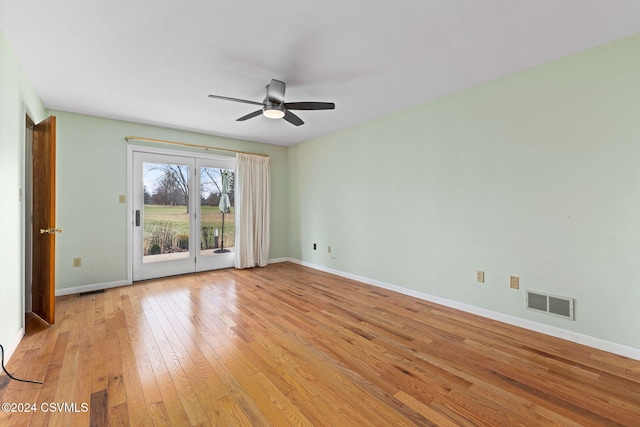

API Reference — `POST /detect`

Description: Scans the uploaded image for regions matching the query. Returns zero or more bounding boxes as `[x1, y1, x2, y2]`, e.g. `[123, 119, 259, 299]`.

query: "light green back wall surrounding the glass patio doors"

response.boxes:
[51, 111, 287, 289]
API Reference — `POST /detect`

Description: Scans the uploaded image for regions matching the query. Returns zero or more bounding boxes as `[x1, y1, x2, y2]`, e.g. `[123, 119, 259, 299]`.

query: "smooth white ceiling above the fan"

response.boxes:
[0, 0, 640, 145]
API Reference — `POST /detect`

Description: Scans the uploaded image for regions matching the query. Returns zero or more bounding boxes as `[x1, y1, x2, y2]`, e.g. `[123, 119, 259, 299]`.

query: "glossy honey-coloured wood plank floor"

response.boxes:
[0, 263, 640, 426]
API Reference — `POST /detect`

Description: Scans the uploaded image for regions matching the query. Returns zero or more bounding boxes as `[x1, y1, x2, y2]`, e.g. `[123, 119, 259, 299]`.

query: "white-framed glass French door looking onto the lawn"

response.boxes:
[131, 151, 235, 281]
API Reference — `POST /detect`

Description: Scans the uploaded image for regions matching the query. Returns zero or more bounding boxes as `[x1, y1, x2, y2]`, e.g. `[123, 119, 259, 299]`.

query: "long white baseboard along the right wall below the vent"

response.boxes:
[287, 258, 640, 360]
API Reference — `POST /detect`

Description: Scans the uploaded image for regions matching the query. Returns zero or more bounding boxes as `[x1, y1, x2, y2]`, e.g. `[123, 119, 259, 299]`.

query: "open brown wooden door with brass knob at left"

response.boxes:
[32, 116, 57, 324]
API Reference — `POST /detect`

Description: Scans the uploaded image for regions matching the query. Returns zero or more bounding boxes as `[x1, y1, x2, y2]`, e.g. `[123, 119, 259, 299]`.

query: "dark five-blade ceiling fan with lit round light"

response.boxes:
[209, 79, 336, 126]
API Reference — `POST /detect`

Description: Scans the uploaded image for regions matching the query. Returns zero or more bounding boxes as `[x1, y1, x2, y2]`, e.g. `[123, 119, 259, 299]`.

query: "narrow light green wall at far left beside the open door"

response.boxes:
[0, 32, 45, 349]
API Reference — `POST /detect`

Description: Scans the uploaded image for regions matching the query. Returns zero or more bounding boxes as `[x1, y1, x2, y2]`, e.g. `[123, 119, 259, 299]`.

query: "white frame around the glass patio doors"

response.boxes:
[127, 145, 236, 284]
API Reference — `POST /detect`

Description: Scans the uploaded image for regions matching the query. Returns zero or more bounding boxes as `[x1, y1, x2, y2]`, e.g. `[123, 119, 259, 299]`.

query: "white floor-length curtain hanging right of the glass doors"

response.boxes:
[235, 153, 271, 268]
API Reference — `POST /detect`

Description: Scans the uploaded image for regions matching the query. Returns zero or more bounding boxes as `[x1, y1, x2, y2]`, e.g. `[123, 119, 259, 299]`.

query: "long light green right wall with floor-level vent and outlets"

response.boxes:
[287, 32, 640, 348]
